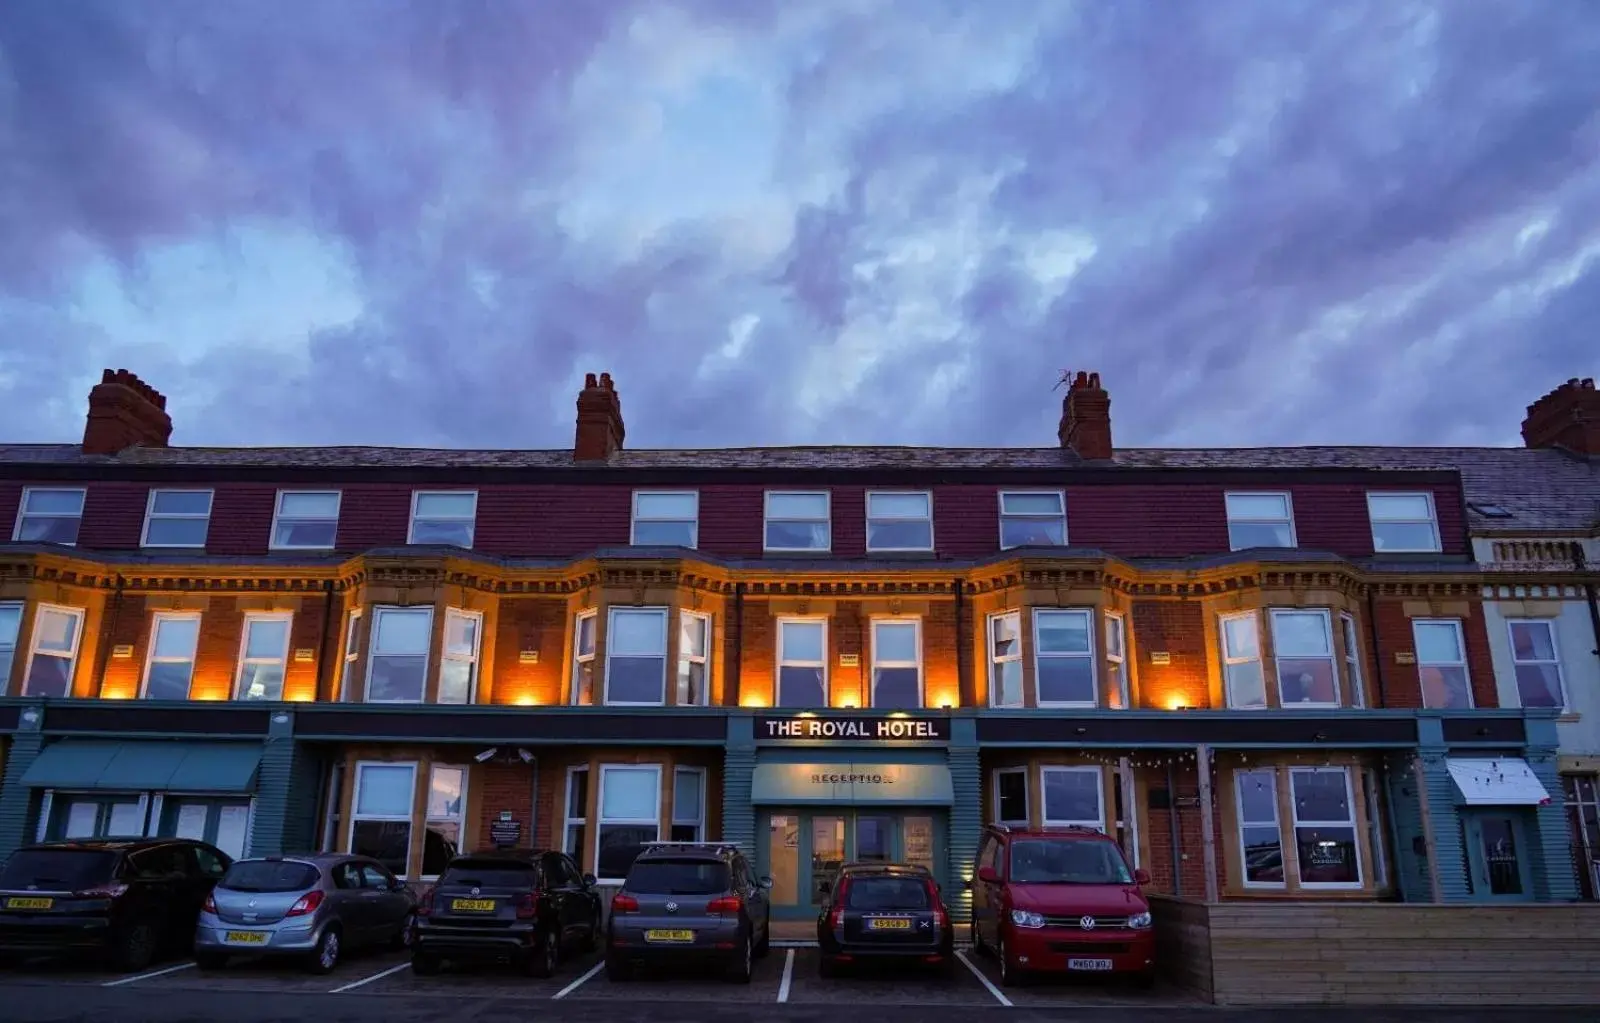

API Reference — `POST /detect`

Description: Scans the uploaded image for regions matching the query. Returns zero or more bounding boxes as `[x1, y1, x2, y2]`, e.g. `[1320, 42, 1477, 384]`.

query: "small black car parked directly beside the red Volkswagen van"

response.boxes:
[816, 863, 955, 977]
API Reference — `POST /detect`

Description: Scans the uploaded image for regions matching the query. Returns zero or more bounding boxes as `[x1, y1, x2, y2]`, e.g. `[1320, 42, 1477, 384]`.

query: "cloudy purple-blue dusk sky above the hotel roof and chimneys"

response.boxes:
[0, 0, 1600, 447]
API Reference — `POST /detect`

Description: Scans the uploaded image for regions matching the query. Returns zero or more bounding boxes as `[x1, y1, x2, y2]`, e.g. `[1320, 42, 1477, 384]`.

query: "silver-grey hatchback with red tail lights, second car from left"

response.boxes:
[195, 853, 416, 973]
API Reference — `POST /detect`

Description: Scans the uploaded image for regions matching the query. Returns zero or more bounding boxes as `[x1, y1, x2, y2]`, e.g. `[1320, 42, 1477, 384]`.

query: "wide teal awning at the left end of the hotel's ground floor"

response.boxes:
[22, 740, 261, 792]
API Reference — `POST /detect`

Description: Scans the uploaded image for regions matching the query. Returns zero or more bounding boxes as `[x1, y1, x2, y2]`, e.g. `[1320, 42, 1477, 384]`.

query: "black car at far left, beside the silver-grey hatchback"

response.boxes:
[0, 839, 232, 972]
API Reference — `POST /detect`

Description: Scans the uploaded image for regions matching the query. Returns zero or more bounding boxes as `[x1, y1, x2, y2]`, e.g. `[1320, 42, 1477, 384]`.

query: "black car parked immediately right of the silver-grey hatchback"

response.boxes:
[411, 850, 602, 977]
